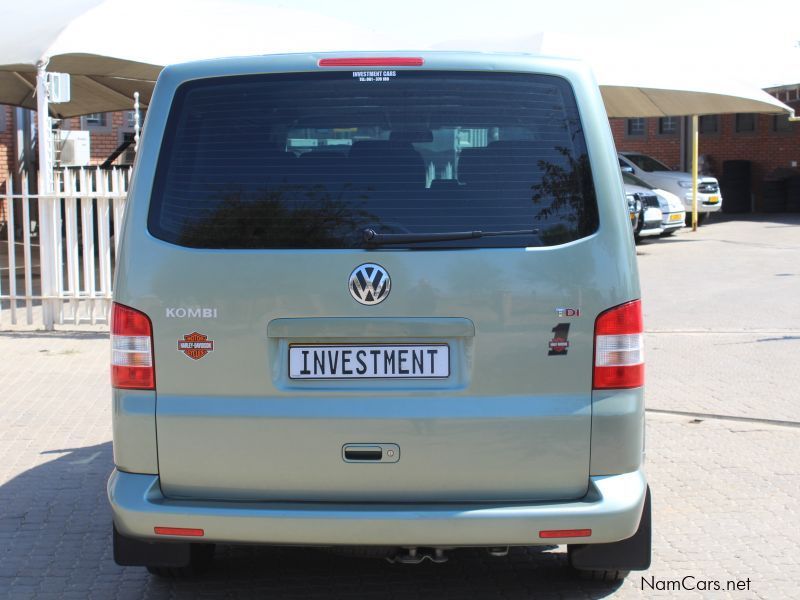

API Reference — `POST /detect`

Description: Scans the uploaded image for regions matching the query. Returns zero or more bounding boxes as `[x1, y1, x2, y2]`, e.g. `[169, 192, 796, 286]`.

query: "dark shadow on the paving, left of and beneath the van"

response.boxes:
[0, 442, 619, 600]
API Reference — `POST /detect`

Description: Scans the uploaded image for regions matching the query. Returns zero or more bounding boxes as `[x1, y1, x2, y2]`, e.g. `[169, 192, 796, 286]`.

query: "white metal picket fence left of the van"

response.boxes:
[0, 168, 130, 329]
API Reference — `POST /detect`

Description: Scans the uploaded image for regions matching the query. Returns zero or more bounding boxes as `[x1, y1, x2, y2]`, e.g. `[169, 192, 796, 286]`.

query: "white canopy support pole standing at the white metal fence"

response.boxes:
[36, 60, 56, 331]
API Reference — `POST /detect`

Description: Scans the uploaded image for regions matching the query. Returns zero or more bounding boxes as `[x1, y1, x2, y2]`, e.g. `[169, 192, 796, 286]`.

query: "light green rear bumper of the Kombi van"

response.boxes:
[108, 470, 647, 546]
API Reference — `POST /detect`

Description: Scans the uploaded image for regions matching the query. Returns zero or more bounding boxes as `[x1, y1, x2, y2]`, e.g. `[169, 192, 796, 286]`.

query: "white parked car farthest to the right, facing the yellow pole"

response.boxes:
[618, 152, 722, 222]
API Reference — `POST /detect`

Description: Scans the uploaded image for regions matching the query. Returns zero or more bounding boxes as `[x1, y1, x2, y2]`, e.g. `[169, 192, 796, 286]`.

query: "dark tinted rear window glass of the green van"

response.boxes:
[148, 70, 598, 248]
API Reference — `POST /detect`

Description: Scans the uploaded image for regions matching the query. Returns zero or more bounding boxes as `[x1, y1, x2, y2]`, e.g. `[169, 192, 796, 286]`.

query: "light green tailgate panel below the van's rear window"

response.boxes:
[145, 246, 602, 501]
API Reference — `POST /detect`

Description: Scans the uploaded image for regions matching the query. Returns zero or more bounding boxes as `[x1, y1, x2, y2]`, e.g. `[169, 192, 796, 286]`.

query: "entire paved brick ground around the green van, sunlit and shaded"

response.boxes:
[0, 213, 800, 599]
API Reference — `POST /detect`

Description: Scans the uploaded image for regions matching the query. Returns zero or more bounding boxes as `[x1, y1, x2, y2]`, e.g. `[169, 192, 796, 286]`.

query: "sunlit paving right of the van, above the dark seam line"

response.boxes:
[638, 215, 800, 421]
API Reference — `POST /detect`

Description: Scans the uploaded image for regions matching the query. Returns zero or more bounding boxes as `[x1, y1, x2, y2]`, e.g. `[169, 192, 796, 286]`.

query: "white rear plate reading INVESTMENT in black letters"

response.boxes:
[289, 344, 450, 379]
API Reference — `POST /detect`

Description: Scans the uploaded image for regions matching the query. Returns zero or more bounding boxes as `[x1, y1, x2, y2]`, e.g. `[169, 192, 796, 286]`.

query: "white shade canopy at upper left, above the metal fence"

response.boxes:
[0, 0, 389, 117]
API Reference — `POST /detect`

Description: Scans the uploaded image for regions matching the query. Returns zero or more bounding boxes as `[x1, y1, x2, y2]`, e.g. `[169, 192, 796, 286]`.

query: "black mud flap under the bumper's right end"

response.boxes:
[568, 486, 651, 571]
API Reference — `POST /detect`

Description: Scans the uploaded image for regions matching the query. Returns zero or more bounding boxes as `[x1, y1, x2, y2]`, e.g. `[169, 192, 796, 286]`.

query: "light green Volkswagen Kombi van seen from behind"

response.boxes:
[108, 52, 650, 578]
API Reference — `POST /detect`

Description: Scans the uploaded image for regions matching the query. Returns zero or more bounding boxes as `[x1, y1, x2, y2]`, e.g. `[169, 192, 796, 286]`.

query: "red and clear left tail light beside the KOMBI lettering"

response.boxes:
[111, 302, 156, 390]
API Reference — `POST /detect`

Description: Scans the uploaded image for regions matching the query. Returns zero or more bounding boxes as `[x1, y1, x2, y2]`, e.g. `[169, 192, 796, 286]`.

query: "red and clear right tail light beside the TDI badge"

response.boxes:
[594, 300, 644, 390]
